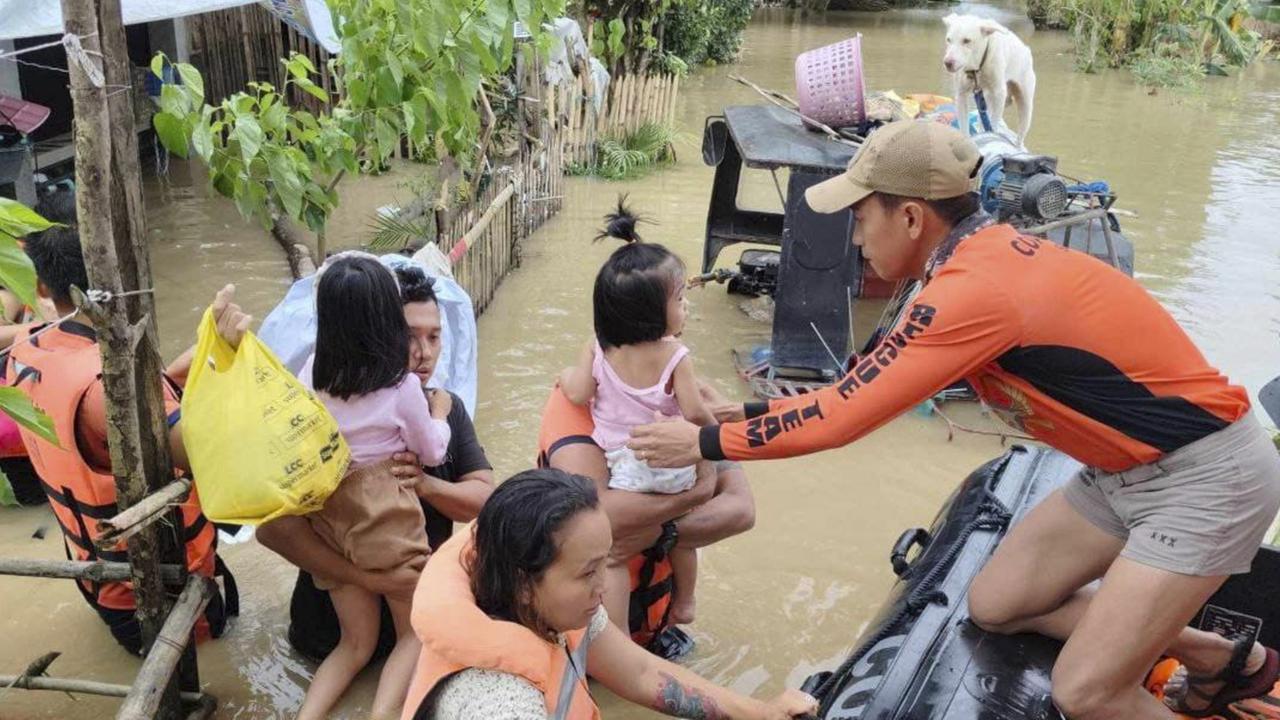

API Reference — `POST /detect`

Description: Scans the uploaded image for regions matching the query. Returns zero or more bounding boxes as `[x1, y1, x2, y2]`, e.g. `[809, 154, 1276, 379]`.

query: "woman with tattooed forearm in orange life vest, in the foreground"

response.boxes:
[402, 469, 818, 720]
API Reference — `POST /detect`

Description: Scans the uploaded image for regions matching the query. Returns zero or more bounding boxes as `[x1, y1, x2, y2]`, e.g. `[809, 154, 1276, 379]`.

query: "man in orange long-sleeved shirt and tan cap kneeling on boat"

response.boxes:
[631, 122, 1280, 720]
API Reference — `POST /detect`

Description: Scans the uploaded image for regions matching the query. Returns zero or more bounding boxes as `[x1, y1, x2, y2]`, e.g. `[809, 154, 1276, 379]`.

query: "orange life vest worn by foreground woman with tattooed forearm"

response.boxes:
[402, 527, 600, 720]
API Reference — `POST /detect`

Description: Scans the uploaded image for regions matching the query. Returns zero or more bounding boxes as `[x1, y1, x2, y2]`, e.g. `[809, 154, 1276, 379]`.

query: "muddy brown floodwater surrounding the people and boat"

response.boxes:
[0, 6, 1280, 720]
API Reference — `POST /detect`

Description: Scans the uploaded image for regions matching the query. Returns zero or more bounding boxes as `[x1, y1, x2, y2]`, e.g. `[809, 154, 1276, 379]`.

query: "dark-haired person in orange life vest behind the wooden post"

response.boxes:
[6, 225, 238, 653]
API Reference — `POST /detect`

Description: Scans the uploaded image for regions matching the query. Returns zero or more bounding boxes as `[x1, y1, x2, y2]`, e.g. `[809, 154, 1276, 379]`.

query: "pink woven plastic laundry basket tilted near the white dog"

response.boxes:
[796, 33, 867, 128]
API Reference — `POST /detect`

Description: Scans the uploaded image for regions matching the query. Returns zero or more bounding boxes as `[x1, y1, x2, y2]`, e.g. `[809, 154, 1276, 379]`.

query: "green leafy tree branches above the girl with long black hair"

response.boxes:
[151, 0, 564, 258]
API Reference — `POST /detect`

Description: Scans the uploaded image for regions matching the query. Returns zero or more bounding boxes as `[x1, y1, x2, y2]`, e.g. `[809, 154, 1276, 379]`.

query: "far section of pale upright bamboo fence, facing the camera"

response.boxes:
[558, 72, 680, 167]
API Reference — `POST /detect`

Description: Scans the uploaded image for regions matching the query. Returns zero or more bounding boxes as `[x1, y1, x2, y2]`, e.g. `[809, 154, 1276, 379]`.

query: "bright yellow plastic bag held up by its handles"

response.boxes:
[182, 303, 351, 525]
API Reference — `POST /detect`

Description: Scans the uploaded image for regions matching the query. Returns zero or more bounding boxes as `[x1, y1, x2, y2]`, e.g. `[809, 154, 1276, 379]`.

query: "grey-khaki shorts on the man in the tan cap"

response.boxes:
[1064, 413, 1280, 577]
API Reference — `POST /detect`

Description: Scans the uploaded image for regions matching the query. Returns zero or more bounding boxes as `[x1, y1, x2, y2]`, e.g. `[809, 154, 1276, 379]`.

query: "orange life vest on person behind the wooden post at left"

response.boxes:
[8, 324, 222, 620]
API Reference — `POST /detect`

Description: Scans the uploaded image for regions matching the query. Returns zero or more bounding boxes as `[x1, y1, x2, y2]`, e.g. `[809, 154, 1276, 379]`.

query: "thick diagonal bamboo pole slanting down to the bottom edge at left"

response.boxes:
[115, 575, 216, 720]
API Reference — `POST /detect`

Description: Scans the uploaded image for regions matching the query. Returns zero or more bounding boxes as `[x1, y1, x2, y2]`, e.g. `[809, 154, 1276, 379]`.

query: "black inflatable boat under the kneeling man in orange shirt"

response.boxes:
[803, 446, 1280, 720]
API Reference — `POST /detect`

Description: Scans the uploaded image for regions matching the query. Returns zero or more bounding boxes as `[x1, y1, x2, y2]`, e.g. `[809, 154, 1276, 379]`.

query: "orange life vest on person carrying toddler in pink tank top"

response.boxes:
[538, 387, 672, 648]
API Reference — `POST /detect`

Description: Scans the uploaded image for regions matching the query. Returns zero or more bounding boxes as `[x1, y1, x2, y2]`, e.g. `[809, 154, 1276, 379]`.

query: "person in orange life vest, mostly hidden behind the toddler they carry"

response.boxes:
[538, 387, 755, 659]
